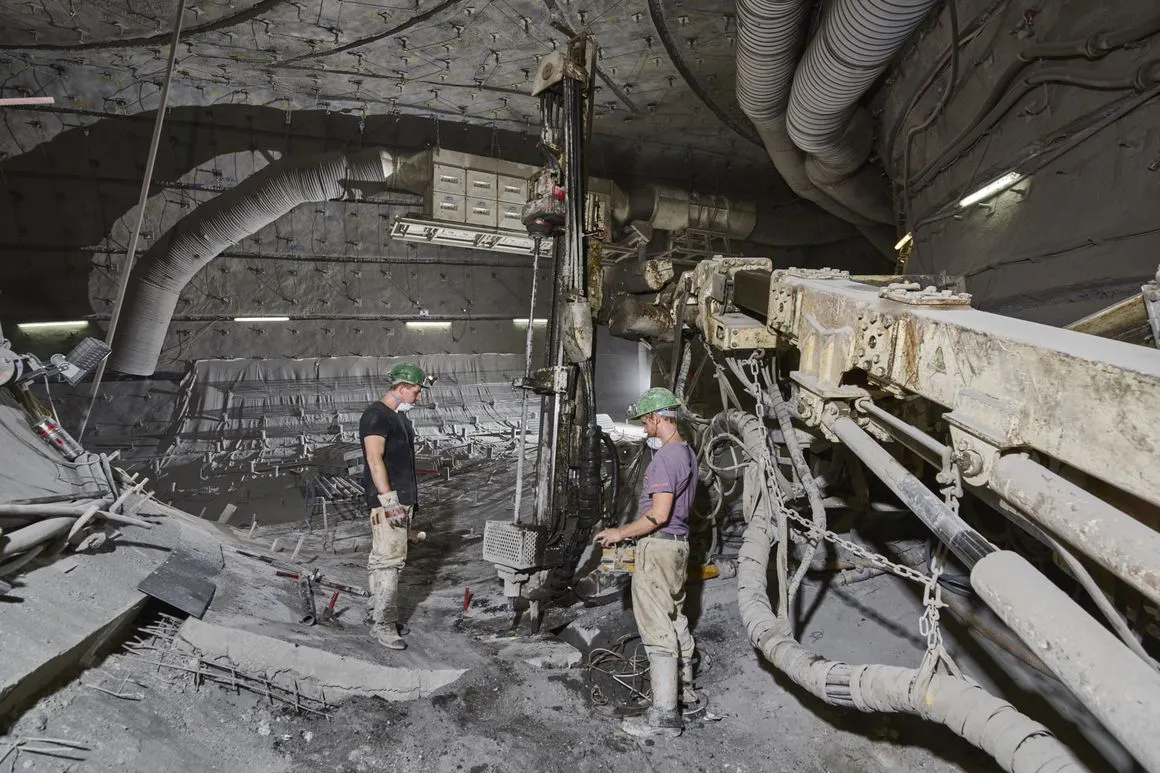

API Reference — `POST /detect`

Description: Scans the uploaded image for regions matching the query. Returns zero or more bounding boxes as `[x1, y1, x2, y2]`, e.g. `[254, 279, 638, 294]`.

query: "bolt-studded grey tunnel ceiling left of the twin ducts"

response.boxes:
[0, 0, 769, 171]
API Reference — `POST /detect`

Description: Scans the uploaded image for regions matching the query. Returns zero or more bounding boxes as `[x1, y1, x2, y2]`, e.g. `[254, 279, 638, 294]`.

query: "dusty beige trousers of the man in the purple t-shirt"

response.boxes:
[632, 537, 694, 660]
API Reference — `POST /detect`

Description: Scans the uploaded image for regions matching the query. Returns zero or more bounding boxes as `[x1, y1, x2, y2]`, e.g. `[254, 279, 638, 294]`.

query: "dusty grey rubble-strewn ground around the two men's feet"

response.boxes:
[0, 454, 1131, 773]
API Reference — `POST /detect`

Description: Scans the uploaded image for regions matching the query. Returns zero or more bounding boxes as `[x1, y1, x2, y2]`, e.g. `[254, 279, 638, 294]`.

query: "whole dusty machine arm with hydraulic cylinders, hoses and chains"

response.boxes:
[607, 258, 1160, 772]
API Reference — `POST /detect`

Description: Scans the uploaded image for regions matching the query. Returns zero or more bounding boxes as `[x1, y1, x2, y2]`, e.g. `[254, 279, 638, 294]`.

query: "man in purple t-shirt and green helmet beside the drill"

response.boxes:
[596, 389, 697, 737]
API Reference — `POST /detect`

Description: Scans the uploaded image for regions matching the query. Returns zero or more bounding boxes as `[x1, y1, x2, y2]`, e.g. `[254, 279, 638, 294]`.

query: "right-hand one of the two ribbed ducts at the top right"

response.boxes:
[788, 0, 938, 223]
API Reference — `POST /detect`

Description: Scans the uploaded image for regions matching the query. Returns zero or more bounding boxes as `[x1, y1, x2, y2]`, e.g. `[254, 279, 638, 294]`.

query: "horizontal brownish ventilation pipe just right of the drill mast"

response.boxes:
[612, 185, 857, 247]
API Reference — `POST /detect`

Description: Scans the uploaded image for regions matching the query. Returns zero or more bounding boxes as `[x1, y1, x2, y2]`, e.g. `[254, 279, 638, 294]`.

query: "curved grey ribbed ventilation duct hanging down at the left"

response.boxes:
[109, 149, 426, 376]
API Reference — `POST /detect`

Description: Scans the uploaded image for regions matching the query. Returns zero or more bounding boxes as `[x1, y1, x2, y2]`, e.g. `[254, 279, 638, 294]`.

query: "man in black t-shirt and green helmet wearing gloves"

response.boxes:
[358, 363, 428, 650]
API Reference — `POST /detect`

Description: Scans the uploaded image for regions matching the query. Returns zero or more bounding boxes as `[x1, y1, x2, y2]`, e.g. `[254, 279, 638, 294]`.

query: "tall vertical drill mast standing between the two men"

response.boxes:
[484, 34, 602, 616]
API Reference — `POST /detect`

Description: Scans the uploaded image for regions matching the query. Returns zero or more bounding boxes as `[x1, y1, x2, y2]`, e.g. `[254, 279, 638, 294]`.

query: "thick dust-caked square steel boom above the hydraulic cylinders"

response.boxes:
[723, 268, 1160, 506]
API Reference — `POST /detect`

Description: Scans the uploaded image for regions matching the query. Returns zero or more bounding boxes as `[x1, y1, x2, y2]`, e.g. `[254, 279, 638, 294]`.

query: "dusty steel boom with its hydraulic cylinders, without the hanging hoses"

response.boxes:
[654, 258, 1160, 770]
